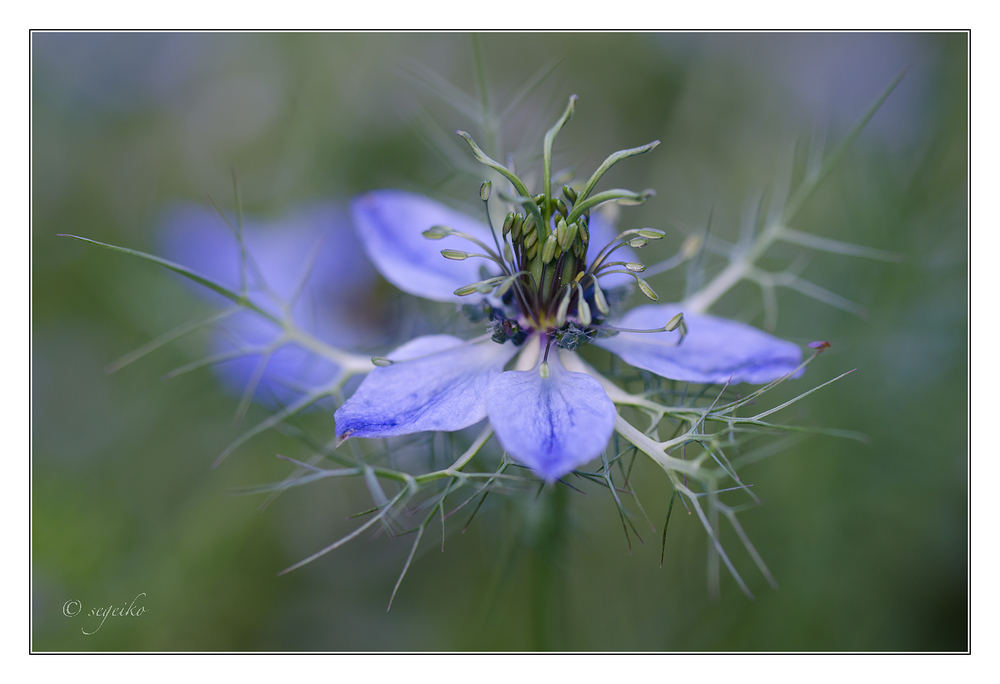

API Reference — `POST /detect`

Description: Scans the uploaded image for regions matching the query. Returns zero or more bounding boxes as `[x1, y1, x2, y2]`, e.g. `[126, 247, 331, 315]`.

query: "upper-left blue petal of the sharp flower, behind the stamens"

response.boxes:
[351, 190, 499, 302]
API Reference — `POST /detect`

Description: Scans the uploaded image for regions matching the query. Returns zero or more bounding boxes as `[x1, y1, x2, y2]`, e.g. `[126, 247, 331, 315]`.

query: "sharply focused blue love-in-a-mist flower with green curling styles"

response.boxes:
[335, 97, 801, 482]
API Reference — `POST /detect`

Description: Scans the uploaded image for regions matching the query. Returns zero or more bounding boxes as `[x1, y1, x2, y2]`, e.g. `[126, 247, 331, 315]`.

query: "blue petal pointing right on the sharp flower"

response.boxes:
[594, 304, 802, 384]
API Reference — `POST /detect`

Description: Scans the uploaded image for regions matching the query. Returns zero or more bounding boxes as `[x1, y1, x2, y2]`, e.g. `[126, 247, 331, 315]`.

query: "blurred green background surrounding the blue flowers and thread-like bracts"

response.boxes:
[31, 33, 968, 651]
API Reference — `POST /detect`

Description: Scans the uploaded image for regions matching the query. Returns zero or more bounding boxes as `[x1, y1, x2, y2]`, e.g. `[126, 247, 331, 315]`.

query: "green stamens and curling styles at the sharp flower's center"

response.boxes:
[424, 95, 677, 356]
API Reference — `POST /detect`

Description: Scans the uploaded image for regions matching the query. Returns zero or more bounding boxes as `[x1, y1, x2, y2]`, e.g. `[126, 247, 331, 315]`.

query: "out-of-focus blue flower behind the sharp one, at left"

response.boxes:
[158, 202, 375, 404]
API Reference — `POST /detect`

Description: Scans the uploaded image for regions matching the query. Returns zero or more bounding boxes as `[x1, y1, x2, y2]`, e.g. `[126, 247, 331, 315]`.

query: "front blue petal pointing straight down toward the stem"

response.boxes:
[486, 354, 615, 482]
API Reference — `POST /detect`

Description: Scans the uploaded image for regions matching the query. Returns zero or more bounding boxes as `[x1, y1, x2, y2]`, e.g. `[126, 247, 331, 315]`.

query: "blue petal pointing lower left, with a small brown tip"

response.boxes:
[334, 335, 518, 438]
